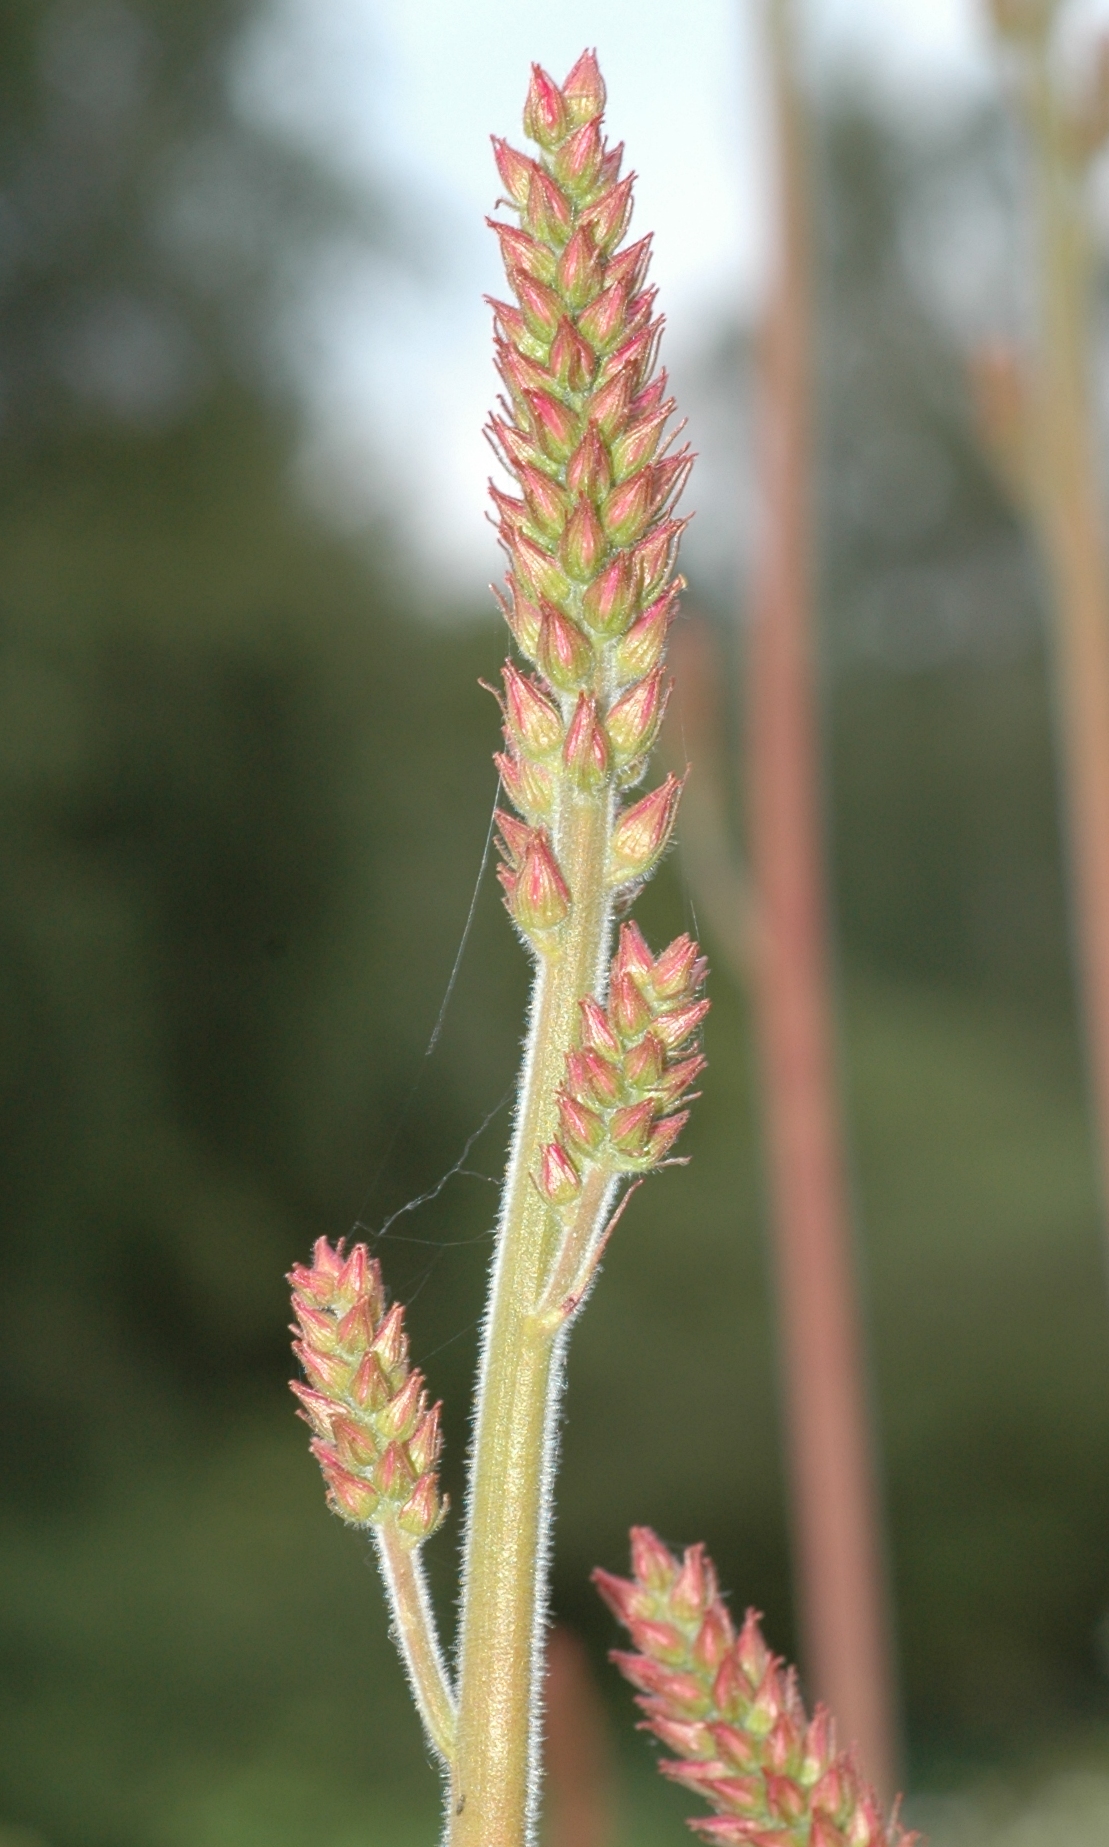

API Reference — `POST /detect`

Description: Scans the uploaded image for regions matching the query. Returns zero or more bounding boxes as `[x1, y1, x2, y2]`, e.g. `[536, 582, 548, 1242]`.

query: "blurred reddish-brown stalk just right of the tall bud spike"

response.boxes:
[747, 0, 896, 1795]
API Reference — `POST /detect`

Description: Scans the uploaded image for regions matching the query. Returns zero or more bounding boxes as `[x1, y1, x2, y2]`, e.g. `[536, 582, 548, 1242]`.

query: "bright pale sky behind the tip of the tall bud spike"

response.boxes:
[227, 0, 1105, 595]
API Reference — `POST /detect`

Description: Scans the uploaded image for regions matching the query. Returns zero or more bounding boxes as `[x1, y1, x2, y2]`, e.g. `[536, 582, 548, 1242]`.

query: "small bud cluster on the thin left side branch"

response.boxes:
[288, 1237, 445, 1544]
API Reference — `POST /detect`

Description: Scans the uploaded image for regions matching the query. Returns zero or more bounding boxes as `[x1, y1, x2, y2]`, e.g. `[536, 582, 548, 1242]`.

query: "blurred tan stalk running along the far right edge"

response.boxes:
[1030, 44, 1109, 1270]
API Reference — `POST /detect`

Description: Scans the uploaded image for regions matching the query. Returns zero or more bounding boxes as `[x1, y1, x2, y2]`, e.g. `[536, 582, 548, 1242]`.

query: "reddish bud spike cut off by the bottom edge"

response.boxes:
[593, 1527, 919, 1847]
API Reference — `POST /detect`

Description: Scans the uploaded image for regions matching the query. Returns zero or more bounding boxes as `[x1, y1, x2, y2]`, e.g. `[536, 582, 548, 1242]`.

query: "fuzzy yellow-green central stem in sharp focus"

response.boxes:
[447, 791, 612, 1847]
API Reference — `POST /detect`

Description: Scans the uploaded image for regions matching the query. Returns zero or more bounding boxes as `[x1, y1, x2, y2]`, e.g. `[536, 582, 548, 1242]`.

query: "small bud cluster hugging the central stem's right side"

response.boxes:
[536, 924, 708, 1210]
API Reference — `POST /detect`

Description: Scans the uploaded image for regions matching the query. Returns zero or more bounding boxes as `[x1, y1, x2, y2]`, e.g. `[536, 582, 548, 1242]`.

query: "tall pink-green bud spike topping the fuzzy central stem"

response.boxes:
[488, 52, 691, 953]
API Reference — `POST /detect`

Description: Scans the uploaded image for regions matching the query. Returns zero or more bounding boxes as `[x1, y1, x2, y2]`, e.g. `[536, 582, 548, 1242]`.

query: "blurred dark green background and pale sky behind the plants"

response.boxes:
[0, 0, 1109, 1847]
